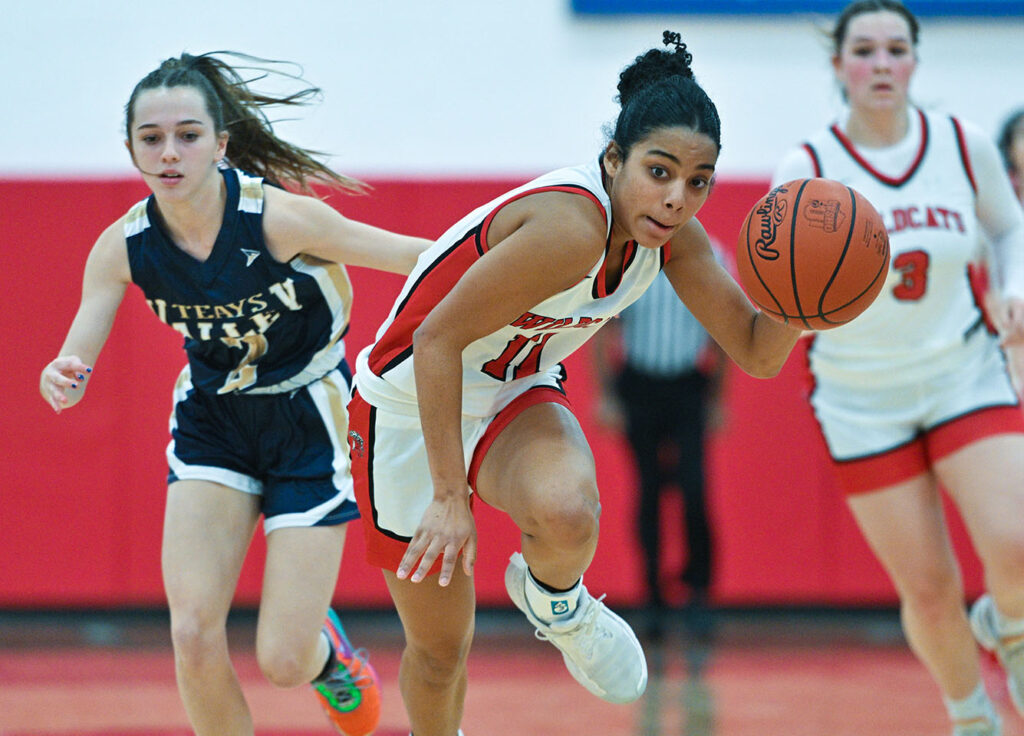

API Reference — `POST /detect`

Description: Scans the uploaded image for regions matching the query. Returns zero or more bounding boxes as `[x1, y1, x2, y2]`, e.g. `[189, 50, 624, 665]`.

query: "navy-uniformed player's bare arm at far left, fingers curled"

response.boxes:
[39, 220, 131, 414]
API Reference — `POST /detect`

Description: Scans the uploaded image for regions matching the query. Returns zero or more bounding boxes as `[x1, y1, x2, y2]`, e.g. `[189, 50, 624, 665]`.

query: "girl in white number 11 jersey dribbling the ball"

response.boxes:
[349, 32, 799, 736]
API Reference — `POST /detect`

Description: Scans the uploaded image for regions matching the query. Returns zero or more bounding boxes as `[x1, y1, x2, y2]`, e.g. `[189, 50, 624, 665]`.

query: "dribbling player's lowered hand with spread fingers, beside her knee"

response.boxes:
[396, 493, 476, 586]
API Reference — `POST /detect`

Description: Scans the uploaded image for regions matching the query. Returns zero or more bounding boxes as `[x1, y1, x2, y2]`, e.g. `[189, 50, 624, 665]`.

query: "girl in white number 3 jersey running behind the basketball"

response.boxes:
[773, 0, 1024, 736]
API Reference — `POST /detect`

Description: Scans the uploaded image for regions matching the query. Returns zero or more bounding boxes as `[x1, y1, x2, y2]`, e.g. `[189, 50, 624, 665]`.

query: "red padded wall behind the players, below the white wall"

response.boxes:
[0, 179, 981, 608]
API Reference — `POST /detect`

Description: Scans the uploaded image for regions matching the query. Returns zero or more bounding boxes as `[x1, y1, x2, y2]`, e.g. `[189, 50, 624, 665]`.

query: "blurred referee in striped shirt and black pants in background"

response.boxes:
[593, 273, 726, 637]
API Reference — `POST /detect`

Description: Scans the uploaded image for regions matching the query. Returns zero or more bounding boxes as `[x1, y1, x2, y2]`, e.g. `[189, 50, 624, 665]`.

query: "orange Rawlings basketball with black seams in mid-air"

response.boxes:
[736, 179, 889, 330]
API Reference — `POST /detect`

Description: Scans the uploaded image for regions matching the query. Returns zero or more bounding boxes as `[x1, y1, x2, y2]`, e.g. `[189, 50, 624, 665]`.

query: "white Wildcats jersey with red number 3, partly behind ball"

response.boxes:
[804, 110, 982, 382]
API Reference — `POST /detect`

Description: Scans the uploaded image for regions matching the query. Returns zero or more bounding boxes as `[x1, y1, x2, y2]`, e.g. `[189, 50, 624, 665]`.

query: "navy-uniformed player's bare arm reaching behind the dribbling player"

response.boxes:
[263, 186, 431, 275]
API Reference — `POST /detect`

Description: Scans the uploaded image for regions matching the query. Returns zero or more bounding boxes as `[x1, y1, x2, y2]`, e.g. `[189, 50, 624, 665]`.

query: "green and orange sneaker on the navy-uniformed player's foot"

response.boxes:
[312, 609, 381, 736]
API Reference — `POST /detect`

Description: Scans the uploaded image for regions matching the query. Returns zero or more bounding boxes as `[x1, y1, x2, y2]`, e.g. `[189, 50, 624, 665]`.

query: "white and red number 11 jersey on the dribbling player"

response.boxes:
[355, 161, 669, 417]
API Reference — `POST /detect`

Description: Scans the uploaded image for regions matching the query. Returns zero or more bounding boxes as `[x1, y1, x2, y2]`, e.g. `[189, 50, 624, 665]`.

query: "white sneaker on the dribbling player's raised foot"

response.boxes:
[505, 552, 647, 703]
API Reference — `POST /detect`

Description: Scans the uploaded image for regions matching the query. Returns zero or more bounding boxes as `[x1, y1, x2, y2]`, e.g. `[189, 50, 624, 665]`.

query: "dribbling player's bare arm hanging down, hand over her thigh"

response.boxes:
[397, 192, 605, 586]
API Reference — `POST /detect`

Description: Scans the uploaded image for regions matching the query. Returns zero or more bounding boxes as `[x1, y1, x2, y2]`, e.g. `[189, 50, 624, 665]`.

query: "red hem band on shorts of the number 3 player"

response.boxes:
[833, 405, 1024, 495]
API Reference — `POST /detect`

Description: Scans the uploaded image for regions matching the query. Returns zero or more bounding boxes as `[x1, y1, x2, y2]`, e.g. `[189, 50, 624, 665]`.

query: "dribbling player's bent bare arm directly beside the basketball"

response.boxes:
[665, 219, 802, 378]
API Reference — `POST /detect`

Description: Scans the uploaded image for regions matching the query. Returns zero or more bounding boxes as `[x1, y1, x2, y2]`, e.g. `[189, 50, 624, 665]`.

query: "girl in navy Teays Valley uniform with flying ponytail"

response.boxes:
[40, 54, 428, 736]
